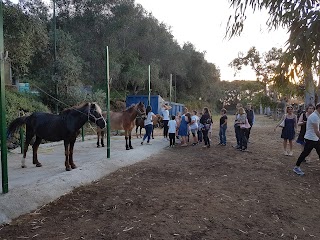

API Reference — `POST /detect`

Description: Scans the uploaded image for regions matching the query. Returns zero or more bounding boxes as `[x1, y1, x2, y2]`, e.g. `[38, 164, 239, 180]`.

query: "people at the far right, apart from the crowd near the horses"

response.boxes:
[274, 103, 320, 176]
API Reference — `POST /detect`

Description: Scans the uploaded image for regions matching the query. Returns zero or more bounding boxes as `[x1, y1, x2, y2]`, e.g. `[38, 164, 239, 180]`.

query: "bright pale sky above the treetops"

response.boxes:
[12, 0, 288, 81]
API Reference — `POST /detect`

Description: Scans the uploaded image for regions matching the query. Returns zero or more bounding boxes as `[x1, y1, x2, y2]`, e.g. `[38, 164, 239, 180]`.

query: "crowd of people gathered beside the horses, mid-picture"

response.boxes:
[141, 104, 254, 151]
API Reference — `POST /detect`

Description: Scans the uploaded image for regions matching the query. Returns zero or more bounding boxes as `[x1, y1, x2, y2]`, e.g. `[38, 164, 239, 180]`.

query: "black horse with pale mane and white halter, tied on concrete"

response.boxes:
[8, 103, 106, 171]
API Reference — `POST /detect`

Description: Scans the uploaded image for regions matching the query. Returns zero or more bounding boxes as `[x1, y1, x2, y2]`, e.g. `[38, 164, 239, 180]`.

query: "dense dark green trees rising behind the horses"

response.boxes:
[5, 0, 220, 109]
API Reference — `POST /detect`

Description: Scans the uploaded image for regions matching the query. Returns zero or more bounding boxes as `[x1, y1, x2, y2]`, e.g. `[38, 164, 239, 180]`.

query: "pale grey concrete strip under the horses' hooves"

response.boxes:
[0, 136, 169, 224]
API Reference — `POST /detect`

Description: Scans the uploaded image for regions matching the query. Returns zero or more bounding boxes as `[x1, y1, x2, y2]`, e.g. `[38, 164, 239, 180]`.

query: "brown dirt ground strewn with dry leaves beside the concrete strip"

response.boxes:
[0, 117, 320, 240]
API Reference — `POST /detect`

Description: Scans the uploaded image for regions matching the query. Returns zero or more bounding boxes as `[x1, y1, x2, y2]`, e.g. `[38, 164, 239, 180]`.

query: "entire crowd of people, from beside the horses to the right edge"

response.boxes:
[141, 99, 320, 175]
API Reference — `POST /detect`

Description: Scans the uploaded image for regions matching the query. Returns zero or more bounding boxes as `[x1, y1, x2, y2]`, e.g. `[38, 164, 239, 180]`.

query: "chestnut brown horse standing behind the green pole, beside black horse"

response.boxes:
[97, 102, 145, 150]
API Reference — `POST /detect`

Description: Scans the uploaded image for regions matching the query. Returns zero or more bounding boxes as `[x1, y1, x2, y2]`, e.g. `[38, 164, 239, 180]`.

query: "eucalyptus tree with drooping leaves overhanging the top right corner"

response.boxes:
[227, 0, 320, 104]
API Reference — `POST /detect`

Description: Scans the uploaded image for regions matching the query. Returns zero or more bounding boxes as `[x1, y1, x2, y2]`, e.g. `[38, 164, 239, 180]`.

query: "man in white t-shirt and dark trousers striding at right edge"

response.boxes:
[293, 103, 320, 176]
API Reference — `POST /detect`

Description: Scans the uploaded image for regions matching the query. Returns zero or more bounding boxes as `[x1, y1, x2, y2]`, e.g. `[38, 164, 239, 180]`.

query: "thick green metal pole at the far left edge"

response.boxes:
[0, 1, 9, 193]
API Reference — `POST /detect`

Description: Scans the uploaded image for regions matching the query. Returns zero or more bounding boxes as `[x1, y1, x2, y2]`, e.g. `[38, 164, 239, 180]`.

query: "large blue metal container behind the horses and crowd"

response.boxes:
[126, 95, 184, 115]
